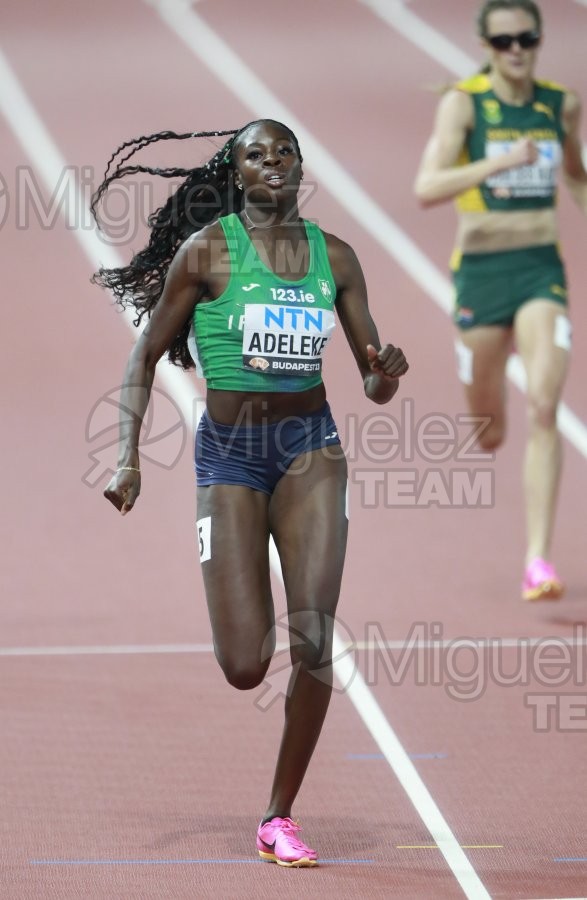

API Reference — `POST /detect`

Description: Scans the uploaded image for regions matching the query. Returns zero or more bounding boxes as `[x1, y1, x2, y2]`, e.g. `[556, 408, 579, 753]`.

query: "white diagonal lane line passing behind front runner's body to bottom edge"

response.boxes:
[0, 40, 490, 900]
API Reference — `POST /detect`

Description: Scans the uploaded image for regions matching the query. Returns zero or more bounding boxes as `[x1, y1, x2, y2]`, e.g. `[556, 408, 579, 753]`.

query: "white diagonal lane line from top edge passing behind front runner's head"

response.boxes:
[145, 0, 587, 458]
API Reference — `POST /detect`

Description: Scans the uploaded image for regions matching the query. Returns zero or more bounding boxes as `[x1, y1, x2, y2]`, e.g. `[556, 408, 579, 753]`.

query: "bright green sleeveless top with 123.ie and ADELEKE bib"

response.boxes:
[190, 213, 336, 392]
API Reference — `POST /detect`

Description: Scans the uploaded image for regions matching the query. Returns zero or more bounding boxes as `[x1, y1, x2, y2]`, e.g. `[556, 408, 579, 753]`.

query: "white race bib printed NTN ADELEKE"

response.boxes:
[243, 304, 335, 375]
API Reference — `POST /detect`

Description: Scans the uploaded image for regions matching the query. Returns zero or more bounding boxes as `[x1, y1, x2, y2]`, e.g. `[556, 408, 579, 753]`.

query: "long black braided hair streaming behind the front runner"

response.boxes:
[90, 119, 302, 369]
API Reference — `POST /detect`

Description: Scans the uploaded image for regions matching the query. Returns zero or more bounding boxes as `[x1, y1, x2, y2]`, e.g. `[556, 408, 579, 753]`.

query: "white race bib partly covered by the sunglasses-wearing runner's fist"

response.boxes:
[485, 141, 562, 198]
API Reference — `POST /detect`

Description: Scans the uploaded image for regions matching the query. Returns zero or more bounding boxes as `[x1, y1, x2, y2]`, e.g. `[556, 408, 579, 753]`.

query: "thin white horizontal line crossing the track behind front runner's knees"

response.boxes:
[0, 636, 587, 658]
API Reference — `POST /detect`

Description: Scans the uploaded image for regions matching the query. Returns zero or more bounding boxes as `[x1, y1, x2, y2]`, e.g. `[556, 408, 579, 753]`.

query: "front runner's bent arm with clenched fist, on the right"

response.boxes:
[325, 234, 408, 403]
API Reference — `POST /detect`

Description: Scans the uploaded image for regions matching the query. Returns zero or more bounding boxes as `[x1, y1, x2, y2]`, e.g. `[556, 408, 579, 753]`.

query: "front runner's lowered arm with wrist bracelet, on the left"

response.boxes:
[104, 231, 211, 515]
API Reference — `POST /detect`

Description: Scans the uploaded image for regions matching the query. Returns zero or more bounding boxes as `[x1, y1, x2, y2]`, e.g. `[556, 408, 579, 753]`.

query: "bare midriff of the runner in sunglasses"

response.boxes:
[456, 209, 559, 253]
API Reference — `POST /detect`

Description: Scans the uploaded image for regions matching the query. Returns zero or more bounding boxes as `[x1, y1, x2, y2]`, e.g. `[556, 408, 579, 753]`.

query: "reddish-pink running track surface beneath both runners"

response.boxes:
[0, 0, 587, 900]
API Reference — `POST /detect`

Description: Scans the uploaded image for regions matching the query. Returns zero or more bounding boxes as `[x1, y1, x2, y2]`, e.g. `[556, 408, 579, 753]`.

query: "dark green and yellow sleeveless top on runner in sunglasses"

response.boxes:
[456, 75, 565, 212]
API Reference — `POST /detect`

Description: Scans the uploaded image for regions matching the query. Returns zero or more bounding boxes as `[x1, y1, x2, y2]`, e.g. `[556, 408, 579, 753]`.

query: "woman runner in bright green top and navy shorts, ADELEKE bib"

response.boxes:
[93, 120, 408, 866]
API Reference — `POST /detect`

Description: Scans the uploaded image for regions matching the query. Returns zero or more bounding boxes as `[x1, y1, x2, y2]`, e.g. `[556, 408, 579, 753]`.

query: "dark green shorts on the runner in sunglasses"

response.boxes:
[453, 244, 567, 329]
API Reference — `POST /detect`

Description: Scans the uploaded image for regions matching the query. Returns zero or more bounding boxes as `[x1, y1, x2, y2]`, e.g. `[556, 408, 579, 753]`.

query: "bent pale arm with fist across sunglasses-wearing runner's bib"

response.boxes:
[414, 89, 537, 207]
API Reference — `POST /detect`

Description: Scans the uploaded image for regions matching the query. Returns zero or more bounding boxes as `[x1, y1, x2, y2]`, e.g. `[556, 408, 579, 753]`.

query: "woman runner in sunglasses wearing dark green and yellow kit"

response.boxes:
[415, 0, 587, 601]
